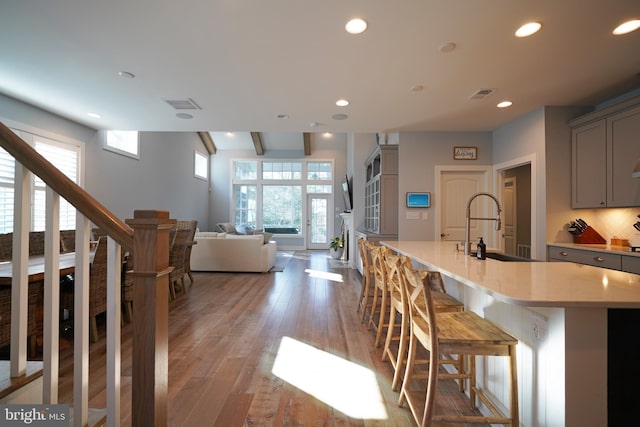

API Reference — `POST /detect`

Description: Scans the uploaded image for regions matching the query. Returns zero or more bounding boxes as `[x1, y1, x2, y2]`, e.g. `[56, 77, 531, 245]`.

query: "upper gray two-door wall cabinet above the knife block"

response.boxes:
[570, 98, 640, 208]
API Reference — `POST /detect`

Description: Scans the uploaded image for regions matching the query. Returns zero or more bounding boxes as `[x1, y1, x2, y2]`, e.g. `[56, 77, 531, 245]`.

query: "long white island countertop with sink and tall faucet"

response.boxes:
[381, 241, 640, 308]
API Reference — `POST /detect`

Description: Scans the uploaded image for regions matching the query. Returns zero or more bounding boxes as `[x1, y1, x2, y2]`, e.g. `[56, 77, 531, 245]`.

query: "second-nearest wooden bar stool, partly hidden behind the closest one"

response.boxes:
[382, 256, 464, 391]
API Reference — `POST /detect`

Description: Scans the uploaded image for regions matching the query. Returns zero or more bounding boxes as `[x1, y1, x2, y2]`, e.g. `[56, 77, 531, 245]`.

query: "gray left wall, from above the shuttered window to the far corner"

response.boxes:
[0, 95, 209, 227]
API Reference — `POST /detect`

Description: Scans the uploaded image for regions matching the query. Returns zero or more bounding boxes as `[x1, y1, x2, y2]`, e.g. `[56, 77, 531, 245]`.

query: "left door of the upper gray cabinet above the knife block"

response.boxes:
[571, 119, 608, 208]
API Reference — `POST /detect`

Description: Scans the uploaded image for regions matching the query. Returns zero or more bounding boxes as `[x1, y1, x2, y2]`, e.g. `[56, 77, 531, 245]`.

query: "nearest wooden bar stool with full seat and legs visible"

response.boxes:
[399, 264, 519, 427]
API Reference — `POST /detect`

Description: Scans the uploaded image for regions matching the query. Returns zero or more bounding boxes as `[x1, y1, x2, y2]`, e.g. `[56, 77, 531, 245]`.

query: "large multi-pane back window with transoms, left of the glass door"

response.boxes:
[232, 160, 333, 234]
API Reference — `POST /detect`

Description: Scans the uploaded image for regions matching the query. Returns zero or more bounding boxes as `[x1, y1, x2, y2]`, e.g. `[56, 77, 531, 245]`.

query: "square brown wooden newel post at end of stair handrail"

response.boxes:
[126, 211, 176, 426]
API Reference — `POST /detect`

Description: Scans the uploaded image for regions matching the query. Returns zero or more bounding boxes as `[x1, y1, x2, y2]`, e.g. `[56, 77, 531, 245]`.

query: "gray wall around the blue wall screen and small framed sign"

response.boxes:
[398, 132, 493, 240]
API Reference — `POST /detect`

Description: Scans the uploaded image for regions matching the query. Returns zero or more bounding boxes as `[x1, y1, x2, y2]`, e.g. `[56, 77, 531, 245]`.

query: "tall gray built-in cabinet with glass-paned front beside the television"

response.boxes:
[364, 145, 398, 237]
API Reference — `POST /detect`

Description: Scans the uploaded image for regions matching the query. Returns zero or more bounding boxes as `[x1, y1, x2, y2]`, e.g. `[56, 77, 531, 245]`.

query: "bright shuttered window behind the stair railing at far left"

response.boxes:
[0, 132, 80, 233]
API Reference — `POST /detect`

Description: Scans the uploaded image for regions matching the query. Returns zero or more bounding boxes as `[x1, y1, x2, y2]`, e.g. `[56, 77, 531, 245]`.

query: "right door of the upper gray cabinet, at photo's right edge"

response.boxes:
[607, 107, 640, 207]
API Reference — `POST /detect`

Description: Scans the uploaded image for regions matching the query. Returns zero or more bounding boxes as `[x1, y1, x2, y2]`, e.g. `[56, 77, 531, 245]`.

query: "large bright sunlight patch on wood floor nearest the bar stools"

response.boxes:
[271, 337, 388, 420]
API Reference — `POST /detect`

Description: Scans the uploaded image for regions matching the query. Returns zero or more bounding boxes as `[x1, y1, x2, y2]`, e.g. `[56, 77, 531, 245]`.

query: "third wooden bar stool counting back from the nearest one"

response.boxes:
[368, 245, 391, 347]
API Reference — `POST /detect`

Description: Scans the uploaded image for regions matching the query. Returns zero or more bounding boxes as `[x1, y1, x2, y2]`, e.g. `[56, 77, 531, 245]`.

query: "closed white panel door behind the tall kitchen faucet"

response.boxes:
[439, 170, 493, 246]
